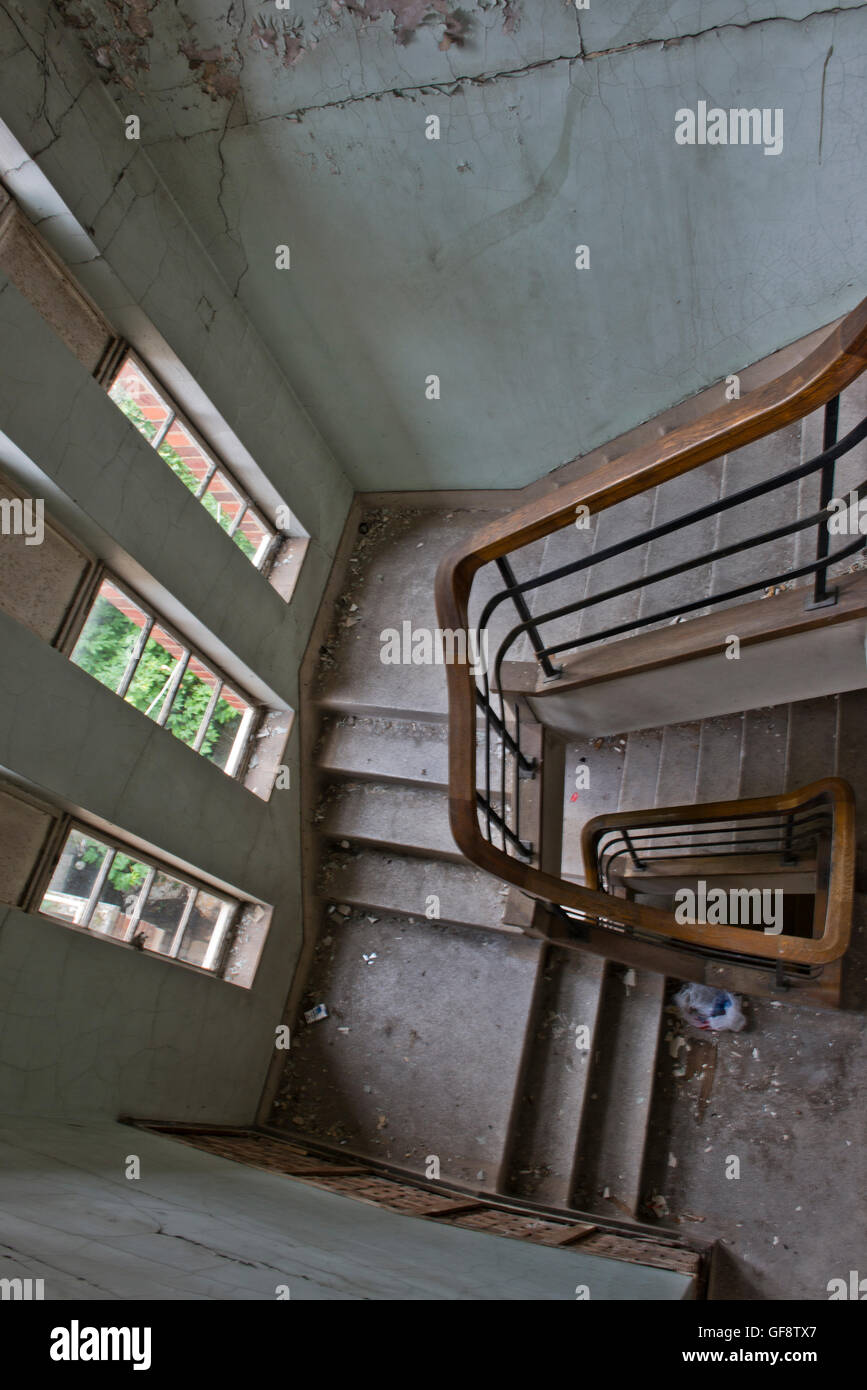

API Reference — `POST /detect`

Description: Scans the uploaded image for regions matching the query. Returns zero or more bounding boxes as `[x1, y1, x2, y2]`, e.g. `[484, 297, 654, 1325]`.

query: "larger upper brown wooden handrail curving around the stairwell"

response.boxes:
[435, 299, 867, 965]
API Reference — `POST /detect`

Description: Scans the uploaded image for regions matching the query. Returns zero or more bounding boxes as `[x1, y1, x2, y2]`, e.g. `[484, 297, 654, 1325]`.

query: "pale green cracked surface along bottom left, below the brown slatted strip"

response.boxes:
[0, 1116, 689, 1295]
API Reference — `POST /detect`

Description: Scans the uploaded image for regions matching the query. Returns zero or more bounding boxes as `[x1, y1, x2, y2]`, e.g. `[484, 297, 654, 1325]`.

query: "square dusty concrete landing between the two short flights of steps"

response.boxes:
[276, 913, 539, 1187]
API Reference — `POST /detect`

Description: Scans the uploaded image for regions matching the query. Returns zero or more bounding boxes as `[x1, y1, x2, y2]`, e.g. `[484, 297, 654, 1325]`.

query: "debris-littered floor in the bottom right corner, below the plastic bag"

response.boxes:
[645, 999, 867, 1300]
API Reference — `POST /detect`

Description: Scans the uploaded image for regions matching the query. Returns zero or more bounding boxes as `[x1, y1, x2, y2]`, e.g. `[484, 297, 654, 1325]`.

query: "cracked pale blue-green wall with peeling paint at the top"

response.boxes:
[15, 0, 867, 488]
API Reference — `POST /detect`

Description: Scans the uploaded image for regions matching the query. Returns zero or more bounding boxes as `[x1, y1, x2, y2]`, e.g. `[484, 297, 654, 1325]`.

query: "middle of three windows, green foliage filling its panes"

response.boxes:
[71, 577, 258, 777]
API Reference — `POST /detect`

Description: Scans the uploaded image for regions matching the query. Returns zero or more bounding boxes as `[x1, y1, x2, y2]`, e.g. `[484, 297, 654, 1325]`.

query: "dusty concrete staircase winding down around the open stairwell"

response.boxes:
[270, 312, 867, 1225]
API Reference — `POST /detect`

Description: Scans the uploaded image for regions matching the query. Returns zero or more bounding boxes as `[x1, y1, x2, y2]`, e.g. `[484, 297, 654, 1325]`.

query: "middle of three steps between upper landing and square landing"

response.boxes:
[320, 783, 461, 862]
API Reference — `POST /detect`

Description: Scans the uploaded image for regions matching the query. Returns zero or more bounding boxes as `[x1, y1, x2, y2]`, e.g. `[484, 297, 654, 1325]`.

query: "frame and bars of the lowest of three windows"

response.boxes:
[33, 813, 240, 984]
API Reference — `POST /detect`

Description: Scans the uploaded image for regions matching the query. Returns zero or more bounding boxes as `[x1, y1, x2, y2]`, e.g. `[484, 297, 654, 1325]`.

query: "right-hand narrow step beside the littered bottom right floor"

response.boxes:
[572, 966, 666, 1216]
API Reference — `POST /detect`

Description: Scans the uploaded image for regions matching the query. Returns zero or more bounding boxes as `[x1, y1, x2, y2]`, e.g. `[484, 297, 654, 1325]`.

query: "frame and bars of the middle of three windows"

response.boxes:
[58, 564, 261, 785]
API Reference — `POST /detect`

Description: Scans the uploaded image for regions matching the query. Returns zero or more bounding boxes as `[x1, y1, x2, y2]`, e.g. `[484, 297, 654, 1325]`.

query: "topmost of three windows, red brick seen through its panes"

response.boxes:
[108, 353, 276, 570]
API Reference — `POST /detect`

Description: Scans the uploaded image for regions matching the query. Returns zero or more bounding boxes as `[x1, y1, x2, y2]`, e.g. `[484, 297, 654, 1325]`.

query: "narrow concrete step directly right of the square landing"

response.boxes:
[504, 948, 606, 1207]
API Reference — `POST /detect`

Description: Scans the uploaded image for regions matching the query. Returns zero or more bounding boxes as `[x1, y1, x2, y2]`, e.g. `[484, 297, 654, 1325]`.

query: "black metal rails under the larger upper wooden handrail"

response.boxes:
[475, 396, 867, 859]
